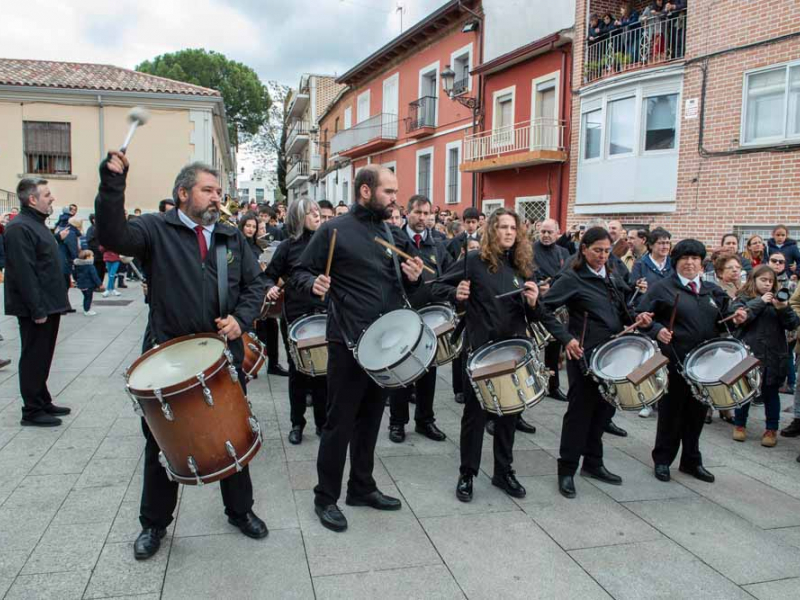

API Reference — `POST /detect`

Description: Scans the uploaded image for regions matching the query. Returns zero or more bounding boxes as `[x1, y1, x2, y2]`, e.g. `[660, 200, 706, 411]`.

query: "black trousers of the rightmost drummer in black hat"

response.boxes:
[653, 363, 708, 468]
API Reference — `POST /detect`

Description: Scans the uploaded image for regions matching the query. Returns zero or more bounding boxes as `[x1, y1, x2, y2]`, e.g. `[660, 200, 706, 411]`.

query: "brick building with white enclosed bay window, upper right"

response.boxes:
[569, 0, 800, 244]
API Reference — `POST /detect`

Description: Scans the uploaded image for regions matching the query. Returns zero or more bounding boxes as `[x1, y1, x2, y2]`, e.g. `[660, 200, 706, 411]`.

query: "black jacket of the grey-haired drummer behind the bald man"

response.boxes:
[265, 229, 326, 324]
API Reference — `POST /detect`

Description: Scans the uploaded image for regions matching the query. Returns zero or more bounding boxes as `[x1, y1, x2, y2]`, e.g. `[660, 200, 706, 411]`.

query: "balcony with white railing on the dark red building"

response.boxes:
[459, 119, 567, 173]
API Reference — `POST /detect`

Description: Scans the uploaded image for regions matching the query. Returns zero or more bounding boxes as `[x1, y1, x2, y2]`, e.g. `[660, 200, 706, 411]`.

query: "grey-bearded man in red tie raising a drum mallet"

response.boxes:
[95, 151, 268, 560]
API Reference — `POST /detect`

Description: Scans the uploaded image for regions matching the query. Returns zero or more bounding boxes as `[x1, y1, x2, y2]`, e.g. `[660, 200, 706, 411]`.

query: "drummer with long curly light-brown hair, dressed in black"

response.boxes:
[434, 208, 563, 502]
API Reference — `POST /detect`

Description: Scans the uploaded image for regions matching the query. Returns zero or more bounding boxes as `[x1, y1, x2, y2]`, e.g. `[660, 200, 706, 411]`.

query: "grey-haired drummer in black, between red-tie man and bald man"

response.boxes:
[266, 196, 328, 444]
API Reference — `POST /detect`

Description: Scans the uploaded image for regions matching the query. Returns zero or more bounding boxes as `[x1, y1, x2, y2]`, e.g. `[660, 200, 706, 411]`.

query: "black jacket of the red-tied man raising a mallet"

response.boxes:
[95, 162, 264, 360]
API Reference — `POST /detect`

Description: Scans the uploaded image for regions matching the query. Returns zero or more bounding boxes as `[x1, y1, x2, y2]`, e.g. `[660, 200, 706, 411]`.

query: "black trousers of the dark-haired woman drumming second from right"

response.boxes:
[558, 360, 616, 475]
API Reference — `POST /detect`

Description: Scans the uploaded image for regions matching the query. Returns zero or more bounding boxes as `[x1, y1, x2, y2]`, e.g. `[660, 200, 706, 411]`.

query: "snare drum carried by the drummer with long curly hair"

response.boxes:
[467, 338, 547, 416]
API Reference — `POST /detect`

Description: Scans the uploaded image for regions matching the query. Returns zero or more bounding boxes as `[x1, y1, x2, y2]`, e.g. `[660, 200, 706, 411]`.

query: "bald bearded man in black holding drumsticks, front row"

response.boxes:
[292, 165, 423, 531]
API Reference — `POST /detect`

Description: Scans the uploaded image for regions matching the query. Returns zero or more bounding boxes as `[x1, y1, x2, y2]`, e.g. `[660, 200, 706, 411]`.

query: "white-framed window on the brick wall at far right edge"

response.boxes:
[742, 63, 800, 144]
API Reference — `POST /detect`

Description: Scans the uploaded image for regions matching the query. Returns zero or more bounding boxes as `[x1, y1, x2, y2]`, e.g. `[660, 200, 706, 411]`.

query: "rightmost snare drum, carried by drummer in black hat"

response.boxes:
[683, 338, 761, 410]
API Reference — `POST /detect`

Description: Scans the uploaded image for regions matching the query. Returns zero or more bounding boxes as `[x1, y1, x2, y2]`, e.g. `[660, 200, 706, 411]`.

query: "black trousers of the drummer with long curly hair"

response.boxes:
[461, 369, 518, 477]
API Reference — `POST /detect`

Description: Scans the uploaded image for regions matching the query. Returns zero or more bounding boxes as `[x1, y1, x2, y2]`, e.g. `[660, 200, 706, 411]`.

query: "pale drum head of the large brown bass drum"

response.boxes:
[128, 337, 225, 391]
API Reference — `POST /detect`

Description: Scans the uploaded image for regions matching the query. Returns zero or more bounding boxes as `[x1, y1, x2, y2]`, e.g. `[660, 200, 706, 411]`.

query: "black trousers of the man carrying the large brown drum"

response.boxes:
[139, 370, 253, 528]
